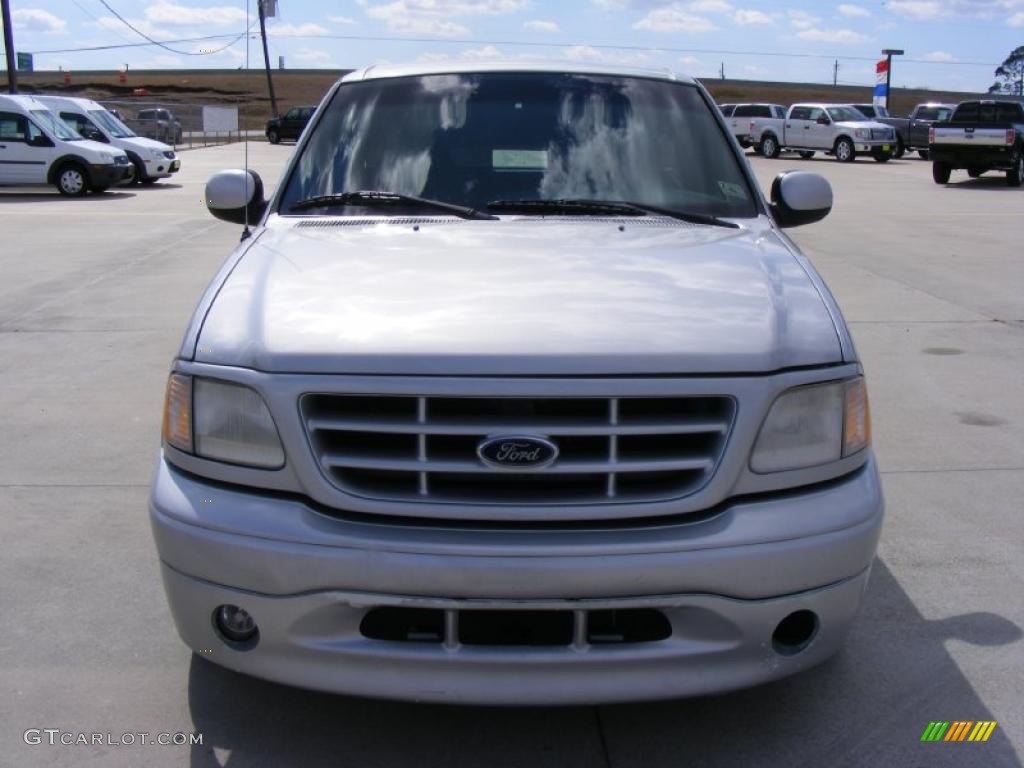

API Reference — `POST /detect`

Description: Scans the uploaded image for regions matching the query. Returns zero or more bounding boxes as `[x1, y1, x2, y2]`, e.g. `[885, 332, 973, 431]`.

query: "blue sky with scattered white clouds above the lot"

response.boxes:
[2, 0, 1024, 90]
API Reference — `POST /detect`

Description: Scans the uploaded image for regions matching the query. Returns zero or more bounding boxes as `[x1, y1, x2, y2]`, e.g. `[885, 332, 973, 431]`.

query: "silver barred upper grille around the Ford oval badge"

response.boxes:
[301, 394, 735, 505]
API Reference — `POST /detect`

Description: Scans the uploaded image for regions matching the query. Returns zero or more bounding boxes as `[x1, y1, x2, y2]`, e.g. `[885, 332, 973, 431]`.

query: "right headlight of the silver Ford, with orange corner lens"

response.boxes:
[751, 376, 871, 473]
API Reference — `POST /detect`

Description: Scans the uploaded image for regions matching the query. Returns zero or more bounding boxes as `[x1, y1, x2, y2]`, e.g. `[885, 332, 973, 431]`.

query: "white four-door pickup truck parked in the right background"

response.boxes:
[750, 103, 896, 163]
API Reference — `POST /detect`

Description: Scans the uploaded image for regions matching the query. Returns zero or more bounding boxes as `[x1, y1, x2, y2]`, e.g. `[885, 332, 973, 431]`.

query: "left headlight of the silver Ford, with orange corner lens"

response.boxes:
[164, 374, 285, 469]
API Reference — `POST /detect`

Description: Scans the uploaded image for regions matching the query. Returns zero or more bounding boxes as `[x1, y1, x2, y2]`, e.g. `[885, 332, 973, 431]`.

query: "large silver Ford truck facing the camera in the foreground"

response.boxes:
[150, 61, 883, 703]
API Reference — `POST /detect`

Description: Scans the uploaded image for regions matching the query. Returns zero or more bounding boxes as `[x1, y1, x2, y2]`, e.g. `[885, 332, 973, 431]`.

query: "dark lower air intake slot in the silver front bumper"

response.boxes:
[359, 606, 672, 648]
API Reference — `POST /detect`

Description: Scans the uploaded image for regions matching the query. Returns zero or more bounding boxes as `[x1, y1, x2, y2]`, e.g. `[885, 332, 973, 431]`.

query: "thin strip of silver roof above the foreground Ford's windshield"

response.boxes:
[342, 59, 695, 84]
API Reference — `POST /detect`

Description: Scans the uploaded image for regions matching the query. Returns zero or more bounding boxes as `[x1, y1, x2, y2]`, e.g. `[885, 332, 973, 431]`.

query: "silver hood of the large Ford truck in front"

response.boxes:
[196, 217, 842, 376]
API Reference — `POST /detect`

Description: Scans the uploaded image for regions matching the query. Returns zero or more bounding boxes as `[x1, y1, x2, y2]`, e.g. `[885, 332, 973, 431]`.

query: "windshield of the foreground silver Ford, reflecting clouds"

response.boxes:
[281, 73, 757, 217]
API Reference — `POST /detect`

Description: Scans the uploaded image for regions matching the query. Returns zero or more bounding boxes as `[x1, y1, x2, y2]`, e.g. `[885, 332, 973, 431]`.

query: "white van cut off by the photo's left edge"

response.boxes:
[0, 95, 134, 198]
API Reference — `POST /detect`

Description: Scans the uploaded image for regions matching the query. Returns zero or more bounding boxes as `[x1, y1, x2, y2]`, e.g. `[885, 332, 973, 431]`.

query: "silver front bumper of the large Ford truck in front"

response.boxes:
[150, 454, 883, 703]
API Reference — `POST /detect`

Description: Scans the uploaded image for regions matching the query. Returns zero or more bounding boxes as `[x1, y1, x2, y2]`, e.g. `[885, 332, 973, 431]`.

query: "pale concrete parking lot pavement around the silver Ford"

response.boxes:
[0, 144, 1024, 768]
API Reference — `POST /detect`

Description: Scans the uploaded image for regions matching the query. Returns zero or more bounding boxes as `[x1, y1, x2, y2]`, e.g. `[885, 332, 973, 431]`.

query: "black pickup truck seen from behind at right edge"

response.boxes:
[928, 100, 1024, 186]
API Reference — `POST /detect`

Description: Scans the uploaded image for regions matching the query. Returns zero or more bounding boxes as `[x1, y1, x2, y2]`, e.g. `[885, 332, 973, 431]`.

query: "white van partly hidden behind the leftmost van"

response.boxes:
[36, 96, 181, 184]
